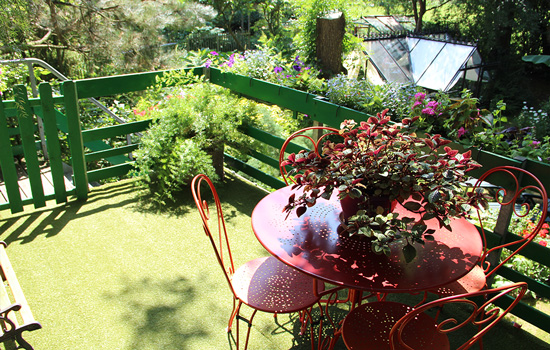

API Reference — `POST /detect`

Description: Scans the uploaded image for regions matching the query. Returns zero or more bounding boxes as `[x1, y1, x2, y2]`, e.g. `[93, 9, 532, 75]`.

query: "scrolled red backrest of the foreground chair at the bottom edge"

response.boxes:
[389, 282, 527, 350]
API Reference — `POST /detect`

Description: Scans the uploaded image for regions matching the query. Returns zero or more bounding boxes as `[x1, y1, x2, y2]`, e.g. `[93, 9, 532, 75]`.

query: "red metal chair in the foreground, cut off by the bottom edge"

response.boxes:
[341, 282, 527, 350]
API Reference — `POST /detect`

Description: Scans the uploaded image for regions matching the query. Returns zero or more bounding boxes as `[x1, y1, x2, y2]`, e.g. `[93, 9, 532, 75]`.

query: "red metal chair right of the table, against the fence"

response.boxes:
[432, 166, 548, 296]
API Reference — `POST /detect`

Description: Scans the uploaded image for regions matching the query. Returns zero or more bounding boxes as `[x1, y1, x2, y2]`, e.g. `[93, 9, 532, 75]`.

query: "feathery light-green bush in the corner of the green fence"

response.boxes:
[135, 75, 264, 203]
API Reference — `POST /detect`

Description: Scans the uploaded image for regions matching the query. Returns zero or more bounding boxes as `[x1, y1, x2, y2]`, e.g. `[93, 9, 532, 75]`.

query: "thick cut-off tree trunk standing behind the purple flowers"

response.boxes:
[316, 12, 346, 78]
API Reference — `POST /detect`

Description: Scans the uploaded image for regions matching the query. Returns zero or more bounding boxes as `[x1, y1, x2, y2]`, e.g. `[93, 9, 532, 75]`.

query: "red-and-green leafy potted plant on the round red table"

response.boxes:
[281, 110, 480, 261]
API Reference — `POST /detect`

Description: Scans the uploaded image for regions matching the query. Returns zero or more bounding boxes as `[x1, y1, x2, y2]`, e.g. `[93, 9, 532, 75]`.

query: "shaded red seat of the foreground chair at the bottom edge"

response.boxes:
[342, 301, 450, 350]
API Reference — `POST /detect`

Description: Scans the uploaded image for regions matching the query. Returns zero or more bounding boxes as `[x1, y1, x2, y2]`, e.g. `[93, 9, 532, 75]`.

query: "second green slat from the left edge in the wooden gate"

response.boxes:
[13, 85, 46, 208]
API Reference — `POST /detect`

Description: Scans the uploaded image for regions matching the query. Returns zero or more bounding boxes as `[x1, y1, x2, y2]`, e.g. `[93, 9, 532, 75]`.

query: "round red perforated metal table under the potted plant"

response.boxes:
[252, 186, 482, 293]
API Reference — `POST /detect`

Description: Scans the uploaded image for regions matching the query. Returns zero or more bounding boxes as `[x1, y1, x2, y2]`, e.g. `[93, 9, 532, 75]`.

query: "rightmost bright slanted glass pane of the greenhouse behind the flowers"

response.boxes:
[417, 43, 475, 91]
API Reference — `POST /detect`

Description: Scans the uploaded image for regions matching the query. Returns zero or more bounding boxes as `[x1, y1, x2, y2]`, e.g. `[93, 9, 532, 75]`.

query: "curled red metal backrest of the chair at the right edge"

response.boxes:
[472, 166, 548, 277]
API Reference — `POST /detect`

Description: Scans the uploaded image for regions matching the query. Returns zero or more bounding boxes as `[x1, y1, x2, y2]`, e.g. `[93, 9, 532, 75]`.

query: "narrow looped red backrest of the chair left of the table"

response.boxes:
[191, 174, 235, 292]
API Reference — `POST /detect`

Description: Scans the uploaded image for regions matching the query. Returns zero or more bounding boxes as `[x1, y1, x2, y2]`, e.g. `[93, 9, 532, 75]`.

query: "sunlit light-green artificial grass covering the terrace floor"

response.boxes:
[0, 175, 550, 350]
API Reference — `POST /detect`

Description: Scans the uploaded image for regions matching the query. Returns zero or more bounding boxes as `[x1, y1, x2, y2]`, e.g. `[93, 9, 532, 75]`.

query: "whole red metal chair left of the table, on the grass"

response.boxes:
[191, 174, 324, 349]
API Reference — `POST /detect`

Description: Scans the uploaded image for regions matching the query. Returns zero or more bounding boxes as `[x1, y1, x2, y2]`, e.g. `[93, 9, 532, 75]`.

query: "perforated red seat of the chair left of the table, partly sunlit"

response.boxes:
[232, 256, 324, 313]
